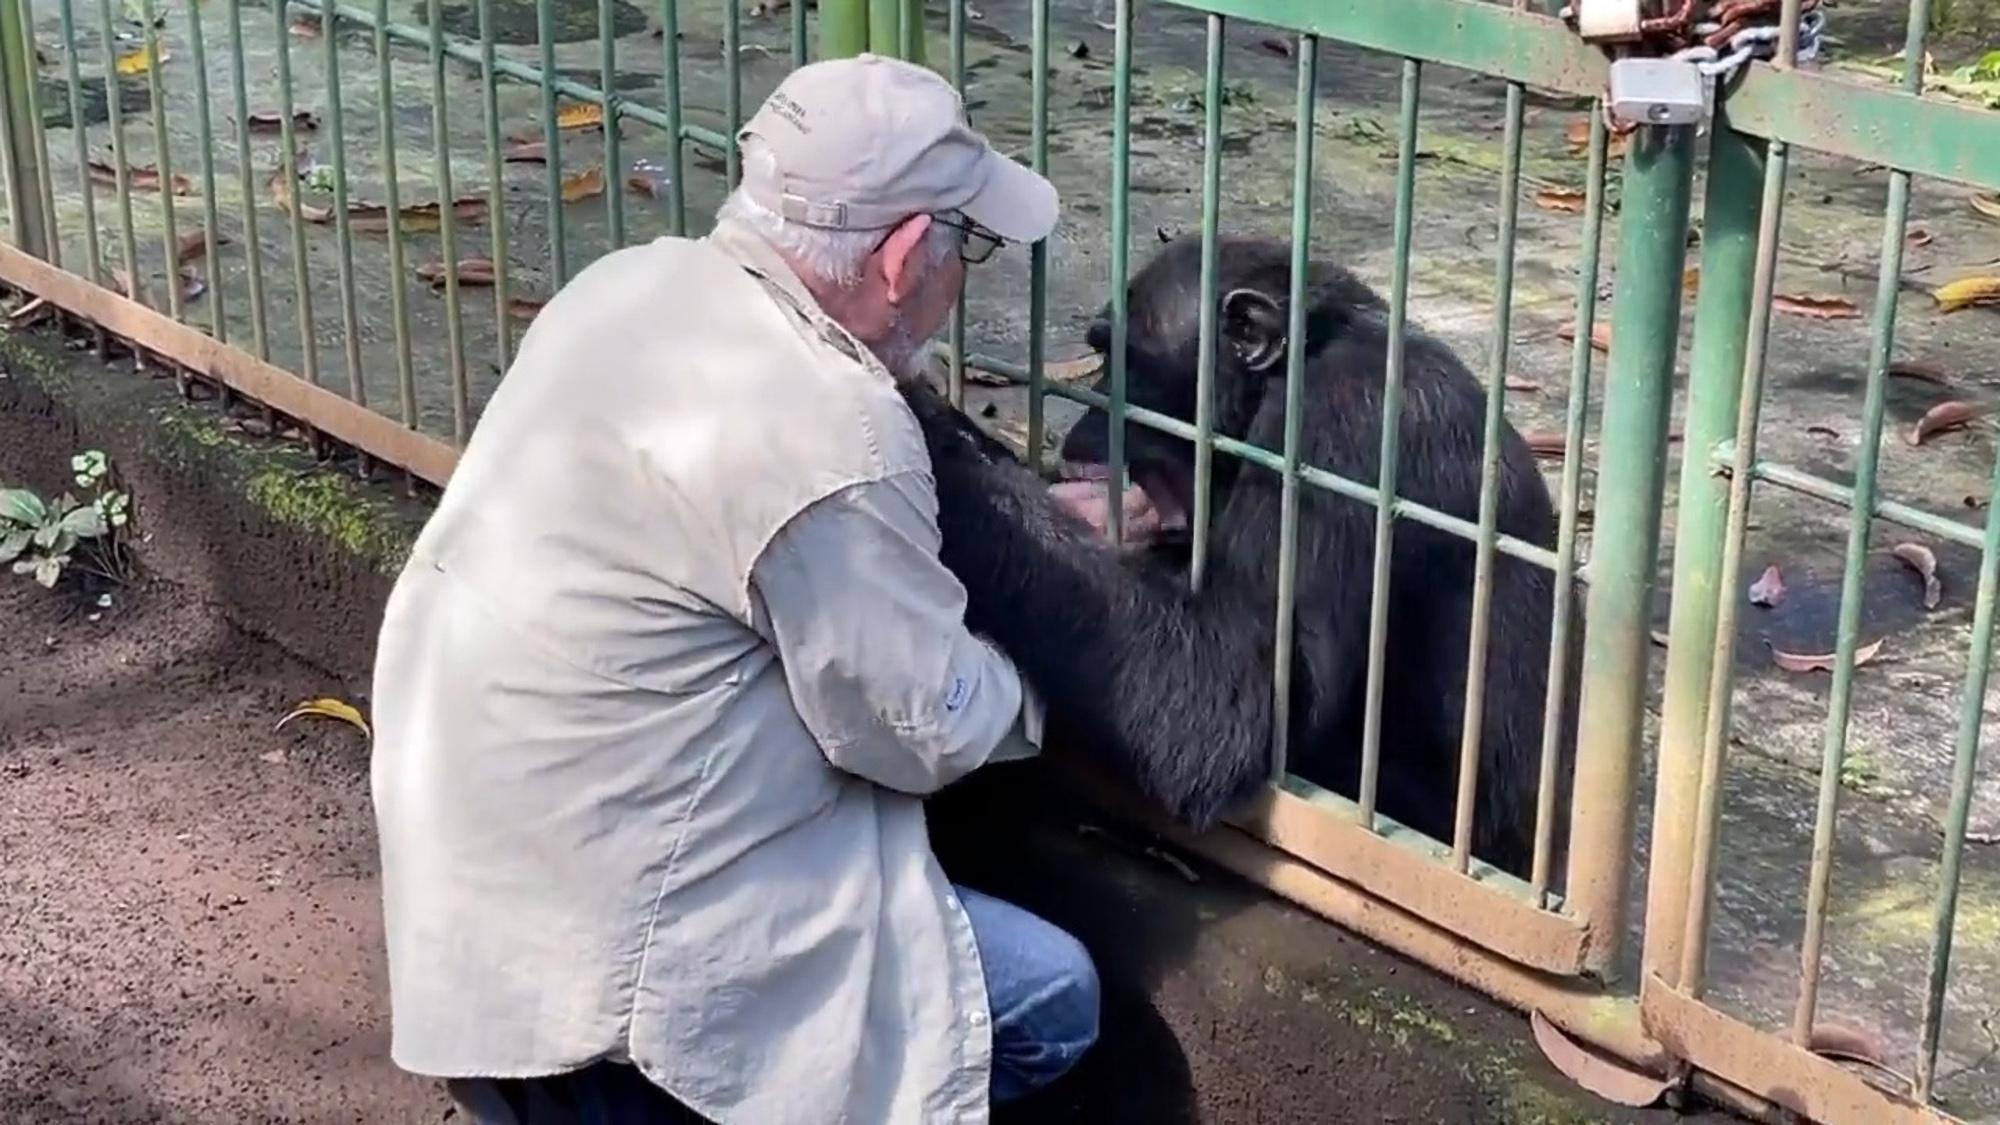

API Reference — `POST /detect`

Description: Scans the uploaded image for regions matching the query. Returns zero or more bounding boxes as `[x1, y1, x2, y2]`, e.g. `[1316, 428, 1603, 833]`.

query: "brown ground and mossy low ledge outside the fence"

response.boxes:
[0, 324, 1722, 1125]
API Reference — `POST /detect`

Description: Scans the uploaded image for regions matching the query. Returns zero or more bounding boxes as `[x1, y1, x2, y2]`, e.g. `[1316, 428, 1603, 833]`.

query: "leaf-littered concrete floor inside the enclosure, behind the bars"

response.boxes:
[3, 0, 2000, 1121]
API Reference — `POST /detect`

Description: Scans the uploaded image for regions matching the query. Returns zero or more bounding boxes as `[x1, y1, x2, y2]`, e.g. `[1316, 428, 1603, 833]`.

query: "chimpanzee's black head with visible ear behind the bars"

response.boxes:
[1062, 238, 1286, 532]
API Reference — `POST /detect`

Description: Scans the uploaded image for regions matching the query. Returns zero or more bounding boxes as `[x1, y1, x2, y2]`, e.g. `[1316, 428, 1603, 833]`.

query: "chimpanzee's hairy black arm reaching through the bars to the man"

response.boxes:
[906, 386, 1272, 829]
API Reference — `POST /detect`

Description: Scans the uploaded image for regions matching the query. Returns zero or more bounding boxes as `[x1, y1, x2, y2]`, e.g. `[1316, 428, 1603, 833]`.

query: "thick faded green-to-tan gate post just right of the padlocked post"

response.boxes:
[1640, 114, 1782, 972]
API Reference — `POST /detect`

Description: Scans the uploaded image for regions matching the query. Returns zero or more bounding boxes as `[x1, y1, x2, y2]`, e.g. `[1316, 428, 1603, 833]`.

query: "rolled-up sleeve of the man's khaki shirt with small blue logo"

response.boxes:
[750, 464, 1042, 795]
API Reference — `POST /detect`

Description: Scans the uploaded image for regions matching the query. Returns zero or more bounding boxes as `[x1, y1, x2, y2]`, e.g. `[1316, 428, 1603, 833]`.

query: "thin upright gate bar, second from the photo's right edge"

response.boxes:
[1780, 0, 1930, 1047]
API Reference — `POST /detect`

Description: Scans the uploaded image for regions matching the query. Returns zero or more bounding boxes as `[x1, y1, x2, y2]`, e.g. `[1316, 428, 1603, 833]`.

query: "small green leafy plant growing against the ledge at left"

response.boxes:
[0, 448, 132, 589]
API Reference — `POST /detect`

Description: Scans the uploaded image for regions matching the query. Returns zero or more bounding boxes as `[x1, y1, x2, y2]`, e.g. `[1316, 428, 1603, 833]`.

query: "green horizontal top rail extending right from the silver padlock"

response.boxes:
[1730, 64, 2000, 188]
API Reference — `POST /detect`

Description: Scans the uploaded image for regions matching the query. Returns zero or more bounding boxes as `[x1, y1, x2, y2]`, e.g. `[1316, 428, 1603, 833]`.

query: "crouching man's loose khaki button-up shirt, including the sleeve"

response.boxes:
[372, 219, 1040, 1125]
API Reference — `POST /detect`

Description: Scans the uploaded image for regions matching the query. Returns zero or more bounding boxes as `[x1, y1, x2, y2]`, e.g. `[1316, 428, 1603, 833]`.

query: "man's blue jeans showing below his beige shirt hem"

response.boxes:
[448, 887, 1098, 1125]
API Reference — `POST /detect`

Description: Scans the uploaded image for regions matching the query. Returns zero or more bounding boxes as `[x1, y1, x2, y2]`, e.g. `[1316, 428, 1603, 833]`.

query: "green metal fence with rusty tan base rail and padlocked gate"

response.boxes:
[0, 0, 2000, 1123]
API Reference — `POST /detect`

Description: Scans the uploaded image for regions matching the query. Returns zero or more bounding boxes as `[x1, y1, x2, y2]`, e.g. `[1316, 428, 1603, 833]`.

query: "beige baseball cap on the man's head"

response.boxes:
[736, 54, 1056, 242]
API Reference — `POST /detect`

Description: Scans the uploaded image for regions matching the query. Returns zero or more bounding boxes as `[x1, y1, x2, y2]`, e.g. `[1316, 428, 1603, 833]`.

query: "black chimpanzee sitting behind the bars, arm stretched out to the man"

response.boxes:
[906, 234, 1580, 877]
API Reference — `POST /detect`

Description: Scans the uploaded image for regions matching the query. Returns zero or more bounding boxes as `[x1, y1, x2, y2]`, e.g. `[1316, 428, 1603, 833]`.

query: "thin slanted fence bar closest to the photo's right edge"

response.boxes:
[1914, 398, 2000, 1105]
